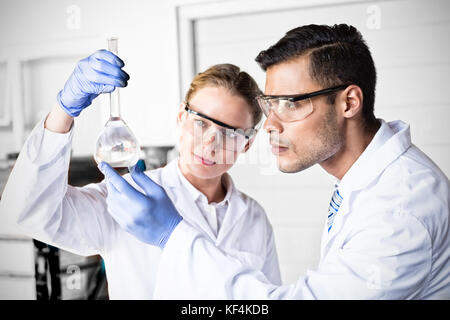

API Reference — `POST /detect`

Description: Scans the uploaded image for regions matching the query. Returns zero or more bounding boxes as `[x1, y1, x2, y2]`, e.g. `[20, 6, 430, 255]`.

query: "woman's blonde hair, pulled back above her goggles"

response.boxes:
[185, 63, 262, 126]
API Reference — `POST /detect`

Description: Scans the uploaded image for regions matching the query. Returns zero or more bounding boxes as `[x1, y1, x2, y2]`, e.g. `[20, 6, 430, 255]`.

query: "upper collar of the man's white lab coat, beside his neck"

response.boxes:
[336, 119, 411, 199]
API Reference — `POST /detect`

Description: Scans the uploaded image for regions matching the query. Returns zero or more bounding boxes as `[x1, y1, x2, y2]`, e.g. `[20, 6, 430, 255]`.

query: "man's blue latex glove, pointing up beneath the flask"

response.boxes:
[98, 162, 183, 248]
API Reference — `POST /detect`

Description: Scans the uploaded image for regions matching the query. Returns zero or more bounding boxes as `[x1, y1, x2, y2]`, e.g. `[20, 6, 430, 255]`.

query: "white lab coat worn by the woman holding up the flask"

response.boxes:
[0, 116, 281, 299]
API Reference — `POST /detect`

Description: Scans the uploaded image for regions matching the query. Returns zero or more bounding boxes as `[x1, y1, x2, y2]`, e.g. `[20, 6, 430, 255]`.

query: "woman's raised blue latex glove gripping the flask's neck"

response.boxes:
[57, 50, 130, 117]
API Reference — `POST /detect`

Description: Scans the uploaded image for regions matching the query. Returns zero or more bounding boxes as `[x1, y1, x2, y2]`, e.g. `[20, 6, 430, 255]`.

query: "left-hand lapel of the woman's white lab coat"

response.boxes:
[162, 159, 216, 241]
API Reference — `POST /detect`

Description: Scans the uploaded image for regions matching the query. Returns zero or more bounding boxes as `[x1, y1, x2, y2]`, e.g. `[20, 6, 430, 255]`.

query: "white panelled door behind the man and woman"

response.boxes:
[180, 0, 450, 282]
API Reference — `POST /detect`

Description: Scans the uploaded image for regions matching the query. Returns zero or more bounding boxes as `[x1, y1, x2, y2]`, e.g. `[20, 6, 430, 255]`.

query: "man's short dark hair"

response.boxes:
[255, 24, 377, 127]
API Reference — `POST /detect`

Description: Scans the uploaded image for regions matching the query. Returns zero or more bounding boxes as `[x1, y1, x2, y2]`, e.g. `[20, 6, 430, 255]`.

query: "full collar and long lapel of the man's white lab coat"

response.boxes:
[321, 119, 411, 259]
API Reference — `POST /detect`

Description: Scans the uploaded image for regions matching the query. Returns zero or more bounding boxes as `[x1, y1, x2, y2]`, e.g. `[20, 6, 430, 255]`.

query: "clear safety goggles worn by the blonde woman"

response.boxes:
[184, 102, 257, 152]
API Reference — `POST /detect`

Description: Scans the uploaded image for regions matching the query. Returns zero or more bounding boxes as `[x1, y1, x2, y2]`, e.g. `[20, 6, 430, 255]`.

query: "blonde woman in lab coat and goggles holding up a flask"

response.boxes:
[1, 50, 281, 299]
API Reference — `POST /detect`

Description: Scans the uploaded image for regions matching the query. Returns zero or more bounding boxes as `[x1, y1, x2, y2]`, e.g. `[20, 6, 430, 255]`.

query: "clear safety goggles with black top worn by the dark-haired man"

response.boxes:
[256, 84, 349, 122]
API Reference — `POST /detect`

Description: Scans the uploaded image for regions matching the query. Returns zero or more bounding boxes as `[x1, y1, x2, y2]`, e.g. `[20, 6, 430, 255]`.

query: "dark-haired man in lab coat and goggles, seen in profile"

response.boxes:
[99, 24, 450, 299]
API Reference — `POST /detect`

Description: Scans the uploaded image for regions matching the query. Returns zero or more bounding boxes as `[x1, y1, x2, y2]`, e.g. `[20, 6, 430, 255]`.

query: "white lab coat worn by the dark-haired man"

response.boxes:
[155, 121, 450, 299]
